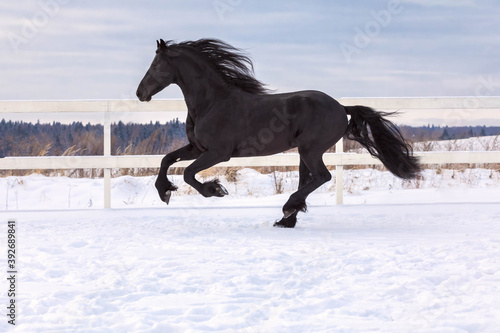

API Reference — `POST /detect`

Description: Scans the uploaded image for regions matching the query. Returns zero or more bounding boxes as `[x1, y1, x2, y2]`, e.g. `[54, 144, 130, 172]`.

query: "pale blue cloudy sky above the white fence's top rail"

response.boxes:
[0, 0, 500, 124]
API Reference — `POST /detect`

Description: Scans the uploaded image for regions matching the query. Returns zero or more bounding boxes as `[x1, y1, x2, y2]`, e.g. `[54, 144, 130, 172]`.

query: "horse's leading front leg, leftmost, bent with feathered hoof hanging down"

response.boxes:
[155, 144, 201, 205]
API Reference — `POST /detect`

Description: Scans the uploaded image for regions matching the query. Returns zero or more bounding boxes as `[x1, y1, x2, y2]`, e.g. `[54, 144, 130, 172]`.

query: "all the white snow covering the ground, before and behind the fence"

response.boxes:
[0, 169, 500, 332]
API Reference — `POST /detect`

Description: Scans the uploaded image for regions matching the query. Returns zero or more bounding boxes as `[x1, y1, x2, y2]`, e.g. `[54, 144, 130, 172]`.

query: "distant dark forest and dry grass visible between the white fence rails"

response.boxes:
[0, 119, 500, 157]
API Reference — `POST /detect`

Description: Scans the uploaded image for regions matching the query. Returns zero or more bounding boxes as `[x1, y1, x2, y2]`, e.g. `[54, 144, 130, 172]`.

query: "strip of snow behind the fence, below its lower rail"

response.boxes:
[0, 169, 500, 209]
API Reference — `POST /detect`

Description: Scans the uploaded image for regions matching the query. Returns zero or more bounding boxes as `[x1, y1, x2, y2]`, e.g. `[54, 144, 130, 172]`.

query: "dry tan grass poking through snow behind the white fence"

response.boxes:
[4, 135, 500, 182]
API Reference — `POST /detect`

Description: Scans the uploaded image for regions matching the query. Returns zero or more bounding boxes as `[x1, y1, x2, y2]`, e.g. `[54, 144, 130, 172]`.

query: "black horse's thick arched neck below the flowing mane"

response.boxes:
[176, 57, 231, 118]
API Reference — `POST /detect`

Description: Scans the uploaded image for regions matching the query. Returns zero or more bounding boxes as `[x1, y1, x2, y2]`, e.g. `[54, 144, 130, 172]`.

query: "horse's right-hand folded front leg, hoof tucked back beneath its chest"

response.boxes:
[184, 150, 230, 197]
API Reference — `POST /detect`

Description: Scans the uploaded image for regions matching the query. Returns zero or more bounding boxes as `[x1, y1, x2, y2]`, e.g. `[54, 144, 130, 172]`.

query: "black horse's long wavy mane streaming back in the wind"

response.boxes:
[166, 39, 269, 94]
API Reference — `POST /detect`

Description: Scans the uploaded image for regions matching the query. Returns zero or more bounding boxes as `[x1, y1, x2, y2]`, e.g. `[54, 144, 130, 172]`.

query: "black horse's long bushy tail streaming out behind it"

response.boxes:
[344, 105, 420, 179]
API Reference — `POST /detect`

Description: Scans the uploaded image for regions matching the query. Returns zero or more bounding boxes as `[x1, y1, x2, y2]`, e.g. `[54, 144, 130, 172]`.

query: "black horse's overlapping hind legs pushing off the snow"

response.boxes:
[274, 149, 332, 228]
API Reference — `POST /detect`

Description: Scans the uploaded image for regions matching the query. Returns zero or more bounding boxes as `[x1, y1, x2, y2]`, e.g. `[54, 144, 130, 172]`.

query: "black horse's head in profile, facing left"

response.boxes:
[136, 39, 178, 102]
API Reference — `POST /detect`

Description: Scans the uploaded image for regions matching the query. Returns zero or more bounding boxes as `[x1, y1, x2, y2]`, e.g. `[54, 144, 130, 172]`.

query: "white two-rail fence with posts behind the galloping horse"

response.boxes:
[0, 97, 500, 208]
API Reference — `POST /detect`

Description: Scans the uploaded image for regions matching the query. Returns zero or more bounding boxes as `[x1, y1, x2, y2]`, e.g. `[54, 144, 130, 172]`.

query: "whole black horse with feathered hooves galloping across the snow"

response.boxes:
[137, 39, 420, 228]
